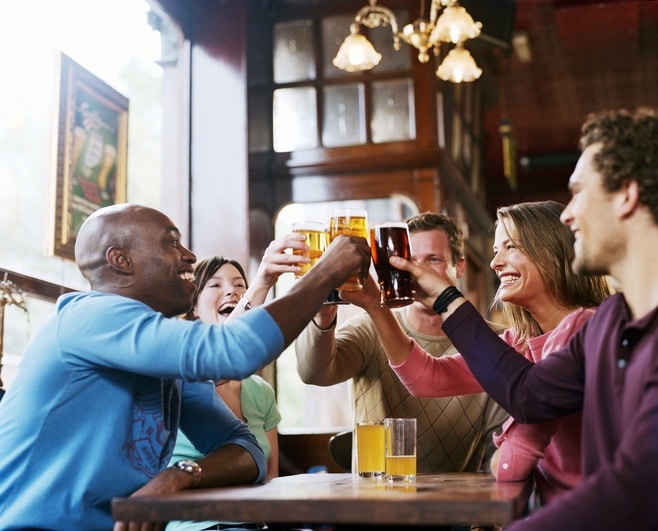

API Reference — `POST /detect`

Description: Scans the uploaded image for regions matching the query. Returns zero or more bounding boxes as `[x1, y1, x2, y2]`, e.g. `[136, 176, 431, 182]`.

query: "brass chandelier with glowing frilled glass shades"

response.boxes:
[333, 0, 482, 83]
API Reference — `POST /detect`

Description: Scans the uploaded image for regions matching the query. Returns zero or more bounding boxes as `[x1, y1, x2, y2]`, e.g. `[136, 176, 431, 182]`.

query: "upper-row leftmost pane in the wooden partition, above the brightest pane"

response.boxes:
[274, 20, 315, 83]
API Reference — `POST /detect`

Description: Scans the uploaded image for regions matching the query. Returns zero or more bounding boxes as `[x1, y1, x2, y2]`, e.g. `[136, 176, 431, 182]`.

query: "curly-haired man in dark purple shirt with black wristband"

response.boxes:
[391, 109, 658, 531]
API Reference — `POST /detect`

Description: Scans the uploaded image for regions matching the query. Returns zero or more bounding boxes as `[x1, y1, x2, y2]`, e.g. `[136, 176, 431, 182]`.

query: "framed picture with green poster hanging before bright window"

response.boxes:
[52, 53, 128, 260]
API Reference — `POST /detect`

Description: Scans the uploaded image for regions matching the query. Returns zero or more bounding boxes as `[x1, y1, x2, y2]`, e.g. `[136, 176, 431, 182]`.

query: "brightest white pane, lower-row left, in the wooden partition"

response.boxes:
[273, 87, 318, 153]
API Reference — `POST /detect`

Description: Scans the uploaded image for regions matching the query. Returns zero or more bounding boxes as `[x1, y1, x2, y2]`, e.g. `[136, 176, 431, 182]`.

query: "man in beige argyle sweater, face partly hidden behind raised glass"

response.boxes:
[295, 212, 507, 473]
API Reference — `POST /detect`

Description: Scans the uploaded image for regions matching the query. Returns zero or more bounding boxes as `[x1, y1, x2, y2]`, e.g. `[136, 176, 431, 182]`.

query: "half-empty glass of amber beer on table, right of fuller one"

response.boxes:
[384, 418, 416, 483]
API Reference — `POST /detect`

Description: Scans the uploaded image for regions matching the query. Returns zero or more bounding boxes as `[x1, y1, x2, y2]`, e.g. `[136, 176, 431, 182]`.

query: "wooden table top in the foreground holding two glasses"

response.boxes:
[112, 473, 531, 526]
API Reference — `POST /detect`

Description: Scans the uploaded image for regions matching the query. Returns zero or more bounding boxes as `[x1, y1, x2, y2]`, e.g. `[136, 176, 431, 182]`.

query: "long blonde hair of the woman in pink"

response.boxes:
[492, 201, 610, 350]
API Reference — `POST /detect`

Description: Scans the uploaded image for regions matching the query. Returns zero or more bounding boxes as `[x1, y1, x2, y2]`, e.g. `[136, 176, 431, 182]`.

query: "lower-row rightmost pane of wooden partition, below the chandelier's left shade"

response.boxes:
[370, 79, 416, 143]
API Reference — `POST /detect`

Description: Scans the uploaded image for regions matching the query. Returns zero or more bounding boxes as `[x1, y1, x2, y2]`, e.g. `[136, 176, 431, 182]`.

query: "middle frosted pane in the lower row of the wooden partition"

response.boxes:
[322, 83, 366, 147]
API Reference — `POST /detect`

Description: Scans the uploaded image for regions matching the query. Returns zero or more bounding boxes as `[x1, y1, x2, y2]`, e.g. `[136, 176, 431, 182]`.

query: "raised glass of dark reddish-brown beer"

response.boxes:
[370, 222, 414, 308]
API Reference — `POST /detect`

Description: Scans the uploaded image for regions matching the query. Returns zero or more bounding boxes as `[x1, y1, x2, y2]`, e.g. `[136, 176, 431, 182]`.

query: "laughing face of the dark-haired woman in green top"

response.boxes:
[194, 263, 247, 324]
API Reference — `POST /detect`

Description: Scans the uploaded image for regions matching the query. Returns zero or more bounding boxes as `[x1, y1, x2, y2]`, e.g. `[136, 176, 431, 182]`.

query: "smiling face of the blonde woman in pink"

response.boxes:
[490, 221, 549, 313]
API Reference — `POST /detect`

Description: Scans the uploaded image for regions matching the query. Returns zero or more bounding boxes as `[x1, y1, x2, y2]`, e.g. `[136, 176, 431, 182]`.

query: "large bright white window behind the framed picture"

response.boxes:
[0, 0, 162, 290]
